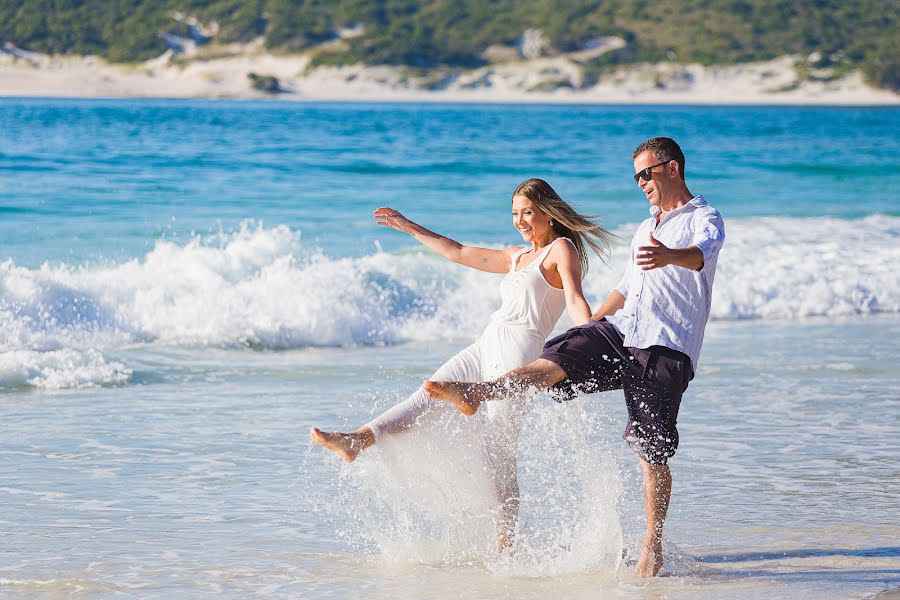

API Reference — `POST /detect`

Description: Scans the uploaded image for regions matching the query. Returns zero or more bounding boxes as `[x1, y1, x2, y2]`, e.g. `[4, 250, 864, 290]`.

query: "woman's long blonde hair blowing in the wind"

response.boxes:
[512, 177, 615, 277]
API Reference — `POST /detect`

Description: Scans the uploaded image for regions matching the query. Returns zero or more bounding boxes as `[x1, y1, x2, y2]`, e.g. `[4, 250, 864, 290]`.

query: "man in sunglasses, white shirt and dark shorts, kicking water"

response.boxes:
[425, 137, 725, 577]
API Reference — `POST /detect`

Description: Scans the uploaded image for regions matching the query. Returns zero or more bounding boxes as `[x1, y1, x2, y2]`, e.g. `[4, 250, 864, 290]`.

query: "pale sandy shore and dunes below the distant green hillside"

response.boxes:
[0, 43, 900, 106]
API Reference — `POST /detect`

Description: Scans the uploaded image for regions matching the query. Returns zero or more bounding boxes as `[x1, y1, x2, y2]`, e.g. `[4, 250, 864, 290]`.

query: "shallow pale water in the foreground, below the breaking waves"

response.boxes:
[0, 316, 900, 598]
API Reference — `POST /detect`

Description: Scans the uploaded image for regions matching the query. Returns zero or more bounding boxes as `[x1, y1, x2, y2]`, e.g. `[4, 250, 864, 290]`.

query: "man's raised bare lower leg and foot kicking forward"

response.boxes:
[424, 358, 566, 415]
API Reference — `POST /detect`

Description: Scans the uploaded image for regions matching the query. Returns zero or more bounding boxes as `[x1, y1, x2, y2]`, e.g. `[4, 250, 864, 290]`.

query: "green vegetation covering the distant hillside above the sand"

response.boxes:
[0, 0, 900, 90]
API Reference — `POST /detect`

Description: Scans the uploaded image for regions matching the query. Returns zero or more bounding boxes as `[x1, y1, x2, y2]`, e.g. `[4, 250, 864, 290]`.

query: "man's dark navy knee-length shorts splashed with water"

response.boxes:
[541, 319, 694, 465]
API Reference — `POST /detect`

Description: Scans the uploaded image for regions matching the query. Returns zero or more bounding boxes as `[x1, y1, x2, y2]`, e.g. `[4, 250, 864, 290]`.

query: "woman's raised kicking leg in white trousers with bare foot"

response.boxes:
[310, 344, 481, 462]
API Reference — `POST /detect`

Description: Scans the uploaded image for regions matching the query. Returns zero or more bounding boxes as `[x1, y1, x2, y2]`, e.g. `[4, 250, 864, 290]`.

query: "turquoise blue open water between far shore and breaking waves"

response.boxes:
[0, 99, 900, 265]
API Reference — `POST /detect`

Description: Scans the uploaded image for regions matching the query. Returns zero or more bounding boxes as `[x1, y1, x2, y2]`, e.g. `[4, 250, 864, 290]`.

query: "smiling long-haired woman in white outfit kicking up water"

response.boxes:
[310, 179, 610, 551]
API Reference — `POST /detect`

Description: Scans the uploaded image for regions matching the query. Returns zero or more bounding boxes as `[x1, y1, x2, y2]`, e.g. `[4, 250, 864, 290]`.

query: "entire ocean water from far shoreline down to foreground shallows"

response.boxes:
[0, 99, 900, 599]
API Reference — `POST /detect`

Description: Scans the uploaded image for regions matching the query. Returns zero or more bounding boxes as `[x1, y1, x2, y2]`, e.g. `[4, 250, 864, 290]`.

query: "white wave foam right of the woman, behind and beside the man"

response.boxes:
[585, 215, 900, 320]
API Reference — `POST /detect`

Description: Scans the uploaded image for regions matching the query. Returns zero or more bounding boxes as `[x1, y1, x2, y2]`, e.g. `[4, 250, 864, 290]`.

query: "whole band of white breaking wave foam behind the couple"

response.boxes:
[0, 216, 900, 387]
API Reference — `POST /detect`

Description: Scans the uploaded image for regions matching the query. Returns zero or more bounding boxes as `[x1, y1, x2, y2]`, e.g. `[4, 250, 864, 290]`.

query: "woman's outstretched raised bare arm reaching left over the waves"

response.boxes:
[375, 207, 516, 273]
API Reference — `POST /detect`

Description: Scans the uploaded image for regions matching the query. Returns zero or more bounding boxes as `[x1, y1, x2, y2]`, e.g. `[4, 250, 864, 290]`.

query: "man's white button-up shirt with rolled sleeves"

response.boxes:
[606, 196, 725, 371]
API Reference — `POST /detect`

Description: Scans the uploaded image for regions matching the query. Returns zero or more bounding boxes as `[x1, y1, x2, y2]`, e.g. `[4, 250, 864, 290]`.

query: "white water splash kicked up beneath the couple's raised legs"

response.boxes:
[302, 397, 623, 577]
